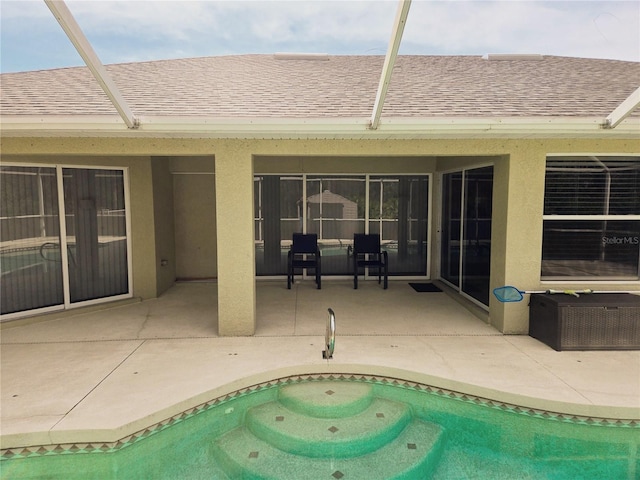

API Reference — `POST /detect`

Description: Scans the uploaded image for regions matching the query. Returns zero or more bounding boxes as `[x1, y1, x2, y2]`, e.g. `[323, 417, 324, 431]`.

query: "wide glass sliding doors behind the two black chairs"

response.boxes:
[254, 175, 429, 276]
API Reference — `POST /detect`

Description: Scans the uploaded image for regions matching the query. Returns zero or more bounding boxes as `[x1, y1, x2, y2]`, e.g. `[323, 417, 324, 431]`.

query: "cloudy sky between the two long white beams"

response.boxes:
[69, 0, 396, 56]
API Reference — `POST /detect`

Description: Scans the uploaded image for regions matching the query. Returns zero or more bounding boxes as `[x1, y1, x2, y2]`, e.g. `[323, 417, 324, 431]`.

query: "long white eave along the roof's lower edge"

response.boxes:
[0, 115, 640, 139]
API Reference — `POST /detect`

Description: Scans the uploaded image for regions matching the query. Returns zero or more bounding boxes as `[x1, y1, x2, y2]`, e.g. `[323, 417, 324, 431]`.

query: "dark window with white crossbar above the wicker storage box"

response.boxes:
[541, 156, 640, 280]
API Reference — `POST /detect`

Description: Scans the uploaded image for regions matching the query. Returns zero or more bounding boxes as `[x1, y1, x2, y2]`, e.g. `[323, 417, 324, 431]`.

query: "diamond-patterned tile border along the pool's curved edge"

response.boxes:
[0, 373, 640, 460]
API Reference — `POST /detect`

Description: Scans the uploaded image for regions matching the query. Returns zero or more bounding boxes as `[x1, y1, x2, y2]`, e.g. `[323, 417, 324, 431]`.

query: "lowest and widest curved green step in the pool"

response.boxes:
[215, 420, 443, 480]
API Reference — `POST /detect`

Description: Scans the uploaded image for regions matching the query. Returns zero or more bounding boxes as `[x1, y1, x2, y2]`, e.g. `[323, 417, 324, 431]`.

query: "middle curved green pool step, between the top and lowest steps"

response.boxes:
[246, 398, 411, 458]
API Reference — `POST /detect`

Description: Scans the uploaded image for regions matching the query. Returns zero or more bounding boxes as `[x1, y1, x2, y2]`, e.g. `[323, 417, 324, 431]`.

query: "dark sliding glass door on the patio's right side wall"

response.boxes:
[440, 167, 493, 305]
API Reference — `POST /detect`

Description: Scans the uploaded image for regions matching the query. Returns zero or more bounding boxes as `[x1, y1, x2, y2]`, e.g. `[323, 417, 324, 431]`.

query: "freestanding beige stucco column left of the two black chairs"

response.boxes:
[215, 148, 256, 336]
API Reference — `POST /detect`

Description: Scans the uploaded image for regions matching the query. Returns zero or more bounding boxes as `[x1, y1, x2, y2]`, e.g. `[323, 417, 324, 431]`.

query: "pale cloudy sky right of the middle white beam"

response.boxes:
[401, 1, 640, 61]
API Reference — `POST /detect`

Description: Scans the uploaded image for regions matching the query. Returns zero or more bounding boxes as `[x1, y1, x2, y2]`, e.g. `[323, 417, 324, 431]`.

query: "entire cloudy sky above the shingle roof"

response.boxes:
[0, 0, 640, 73]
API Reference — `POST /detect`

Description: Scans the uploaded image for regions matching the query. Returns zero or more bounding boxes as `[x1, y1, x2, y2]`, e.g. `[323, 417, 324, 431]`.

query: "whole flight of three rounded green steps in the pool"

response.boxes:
[212, 381, 444, 480]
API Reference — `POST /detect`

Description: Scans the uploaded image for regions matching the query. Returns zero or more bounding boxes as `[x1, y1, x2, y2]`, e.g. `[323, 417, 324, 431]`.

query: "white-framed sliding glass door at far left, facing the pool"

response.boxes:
[0, 166, 129, 314]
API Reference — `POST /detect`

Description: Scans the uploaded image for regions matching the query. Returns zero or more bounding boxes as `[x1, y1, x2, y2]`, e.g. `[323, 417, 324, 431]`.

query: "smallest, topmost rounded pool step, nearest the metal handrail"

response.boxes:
[278, 382, 374, 418]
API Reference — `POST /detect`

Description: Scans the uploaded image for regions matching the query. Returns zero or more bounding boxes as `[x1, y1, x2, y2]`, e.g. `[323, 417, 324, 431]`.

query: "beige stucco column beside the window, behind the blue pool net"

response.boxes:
[489, 148, 546, 334]
